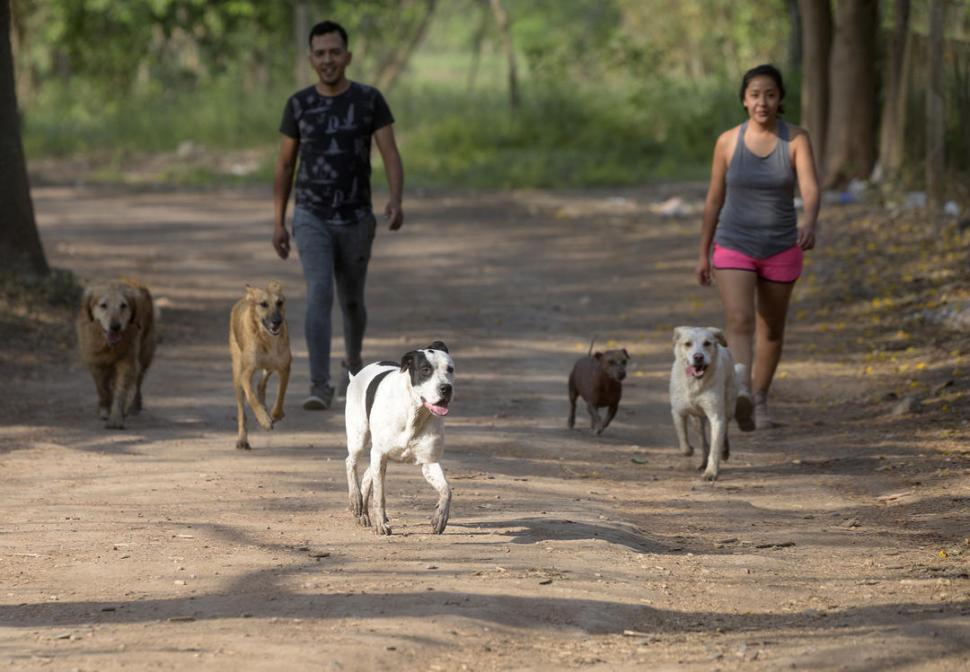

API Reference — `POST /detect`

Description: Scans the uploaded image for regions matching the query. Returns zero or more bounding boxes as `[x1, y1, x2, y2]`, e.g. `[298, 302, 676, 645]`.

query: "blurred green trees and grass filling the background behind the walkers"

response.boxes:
[17, 0, 797, 187]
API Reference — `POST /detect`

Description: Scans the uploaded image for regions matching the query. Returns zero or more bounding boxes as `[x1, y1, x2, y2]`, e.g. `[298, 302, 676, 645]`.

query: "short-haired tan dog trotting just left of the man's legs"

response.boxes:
[229, 280, 293, 450]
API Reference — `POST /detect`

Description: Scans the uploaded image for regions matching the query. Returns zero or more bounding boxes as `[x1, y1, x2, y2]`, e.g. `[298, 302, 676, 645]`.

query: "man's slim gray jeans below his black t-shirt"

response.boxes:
[293, 208, 377, 394]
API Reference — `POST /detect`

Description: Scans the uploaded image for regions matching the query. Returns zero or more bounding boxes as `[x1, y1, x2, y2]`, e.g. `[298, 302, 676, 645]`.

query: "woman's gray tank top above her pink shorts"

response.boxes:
[714, 119, 798, 259]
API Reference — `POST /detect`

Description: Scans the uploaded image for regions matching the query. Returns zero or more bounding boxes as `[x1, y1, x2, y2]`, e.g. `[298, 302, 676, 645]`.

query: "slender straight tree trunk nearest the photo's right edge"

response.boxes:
[926, 0, 946, 213]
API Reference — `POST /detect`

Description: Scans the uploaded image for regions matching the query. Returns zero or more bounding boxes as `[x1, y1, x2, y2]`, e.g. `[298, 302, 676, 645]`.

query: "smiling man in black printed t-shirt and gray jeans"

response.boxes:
[273, 21, 404, 410]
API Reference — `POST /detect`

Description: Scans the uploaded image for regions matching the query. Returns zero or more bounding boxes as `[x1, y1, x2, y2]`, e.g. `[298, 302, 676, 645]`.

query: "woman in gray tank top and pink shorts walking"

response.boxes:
[694, 65, 819, 431]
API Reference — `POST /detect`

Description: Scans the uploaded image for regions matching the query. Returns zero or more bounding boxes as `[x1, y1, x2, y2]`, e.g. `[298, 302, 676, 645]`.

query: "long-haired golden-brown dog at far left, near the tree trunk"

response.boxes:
[74, 278, 155, 429]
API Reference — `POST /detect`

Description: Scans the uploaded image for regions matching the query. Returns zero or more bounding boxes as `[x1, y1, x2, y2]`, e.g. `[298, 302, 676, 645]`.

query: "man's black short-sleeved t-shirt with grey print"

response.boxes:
[280, 82, 394, 226]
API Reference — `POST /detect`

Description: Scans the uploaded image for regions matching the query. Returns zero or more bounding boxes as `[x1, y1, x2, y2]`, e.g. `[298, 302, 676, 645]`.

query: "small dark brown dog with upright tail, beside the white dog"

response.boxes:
[568, 341, 630, 434]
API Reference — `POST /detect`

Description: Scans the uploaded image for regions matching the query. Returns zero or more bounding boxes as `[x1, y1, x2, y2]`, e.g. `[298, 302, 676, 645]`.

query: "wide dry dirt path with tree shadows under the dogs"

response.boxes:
[0, 188, 970, 671]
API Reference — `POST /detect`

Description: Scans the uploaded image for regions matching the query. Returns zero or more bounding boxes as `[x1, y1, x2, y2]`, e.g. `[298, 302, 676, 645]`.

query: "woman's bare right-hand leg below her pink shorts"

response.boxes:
[752, 280, 795, 429]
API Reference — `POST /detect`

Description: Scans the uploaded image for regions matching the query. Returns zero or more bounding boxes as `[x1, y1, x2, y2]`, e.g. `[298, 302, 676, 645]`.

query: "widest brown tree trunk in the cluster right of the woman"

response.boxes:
[822, 0, 879, 187]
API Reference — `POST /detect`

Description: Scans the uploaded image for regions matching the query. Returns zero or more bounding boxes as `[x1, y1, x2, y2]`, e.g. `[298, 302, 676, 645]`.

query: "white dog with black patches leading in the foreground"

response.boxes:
[346, 341, 455, 534]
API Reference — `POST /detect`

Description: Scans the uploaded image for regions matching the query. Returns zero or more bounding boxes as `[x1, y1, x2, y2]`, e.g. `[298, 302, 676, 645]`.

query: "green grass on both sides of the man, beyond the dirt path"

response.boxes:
[25, 63, 739, 188]
